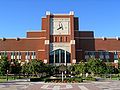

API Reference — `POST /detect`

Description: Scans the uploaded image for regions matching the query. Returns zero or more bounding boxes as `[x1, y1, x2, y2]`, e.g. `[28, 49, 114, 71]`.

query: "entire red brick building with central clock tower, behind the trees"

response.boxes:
[0, 11, 120, 64]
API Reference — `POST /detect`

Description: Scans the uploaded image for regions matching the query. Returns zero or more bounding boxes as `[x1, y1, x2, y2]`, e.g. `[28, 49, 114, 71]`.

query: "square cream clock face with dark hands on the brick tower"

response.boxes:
[51, 18, 70, 35]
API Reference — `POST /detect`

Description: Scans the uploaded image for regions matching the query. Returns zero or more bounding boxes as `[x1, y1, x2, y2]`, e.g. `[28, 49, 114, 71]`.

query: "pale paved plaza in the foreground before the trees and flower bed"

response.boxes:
[0, 80, 120, 90]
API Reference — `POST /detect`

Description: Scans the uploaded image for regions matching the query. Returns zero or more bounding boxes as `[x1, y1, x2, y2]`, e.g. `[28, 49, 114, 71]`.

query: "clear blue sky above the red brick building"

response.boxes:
[0, 0, 120, 38]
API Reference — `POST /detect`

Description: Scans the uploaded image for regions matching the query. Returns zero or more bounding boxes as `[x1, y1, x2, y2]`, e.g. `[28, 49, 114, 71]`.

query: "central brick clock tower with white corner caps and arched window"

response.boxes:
[44, 11, 76, 65]
